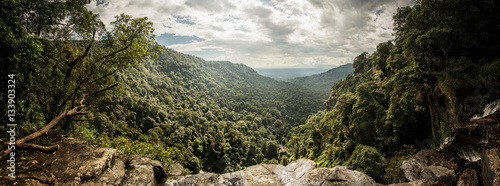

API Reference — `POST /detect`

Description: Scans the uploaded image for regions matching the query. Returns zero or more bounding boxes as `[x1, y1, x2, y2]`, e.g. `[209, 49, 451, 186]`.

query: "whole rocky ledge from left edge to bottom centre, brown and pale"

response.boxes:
[0, 132, 377, 186]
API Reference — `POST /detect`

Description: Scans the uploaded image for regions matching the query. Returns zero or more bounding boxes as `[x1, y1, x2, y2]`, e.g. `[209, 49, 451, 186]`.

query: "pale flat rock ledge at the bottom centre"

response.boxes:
[164, 159, 377, 186]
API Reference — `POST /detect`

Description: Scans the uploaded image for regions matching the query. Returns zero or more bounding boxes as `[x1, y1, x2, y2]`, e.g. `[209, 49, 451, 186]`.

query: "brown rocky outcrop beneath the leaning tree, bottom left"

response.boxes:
[0, 137, 167, 186]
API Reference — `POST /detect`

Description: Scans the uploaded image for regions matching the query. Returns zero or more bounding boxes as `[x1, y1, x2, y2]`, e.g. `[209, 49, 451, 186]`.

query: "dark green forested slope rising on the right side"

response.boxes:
[287, 0, 500, 183]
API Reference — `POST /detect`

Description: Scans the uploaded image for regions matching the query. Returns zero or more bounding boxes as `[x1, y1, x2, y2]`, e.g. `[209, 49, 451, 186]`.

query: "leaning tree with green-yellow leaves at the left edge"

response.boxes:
[0, 0, 160, 158]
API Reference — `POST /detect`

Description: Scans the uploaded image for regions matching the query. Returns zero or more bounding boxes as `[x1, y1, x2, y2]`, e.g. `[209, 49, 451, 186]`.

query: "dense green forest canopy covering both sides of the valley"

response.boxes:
[0, 0, 500, 183]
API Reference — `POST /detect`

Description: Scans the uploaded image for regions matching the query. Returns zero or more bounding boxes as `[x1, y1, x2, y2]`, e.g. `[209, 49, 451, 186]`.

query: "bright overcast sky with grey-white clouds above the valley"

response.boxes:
[88, 0, 411, 68]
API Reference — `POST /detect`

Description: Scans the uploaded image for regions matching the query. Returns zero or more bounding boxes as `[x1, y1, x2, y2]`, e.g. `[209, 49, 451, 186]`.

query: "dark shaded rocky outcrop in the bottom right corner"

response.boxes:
[400, 111, 500, 185]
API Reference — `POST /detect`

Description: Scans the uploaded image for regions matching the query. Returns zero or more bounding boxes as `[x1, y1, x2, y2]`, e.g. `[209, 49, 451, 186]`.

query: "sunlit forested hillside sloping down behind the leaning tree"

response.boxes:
[93, 48, 324, 172]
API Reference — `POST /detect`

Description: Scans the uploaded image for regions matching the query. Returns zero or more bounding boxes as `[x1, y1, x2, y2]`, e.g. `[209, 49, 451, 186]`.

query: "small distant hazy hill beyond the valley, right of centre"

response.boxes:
[288, 63, 354, 95]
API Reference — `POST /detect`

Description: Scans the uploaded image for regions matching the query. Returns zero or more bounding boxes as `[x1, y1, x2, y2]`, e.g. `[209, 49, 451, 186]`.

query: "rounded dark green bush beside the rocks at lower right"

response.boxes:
[343, 145, 387, 181]
